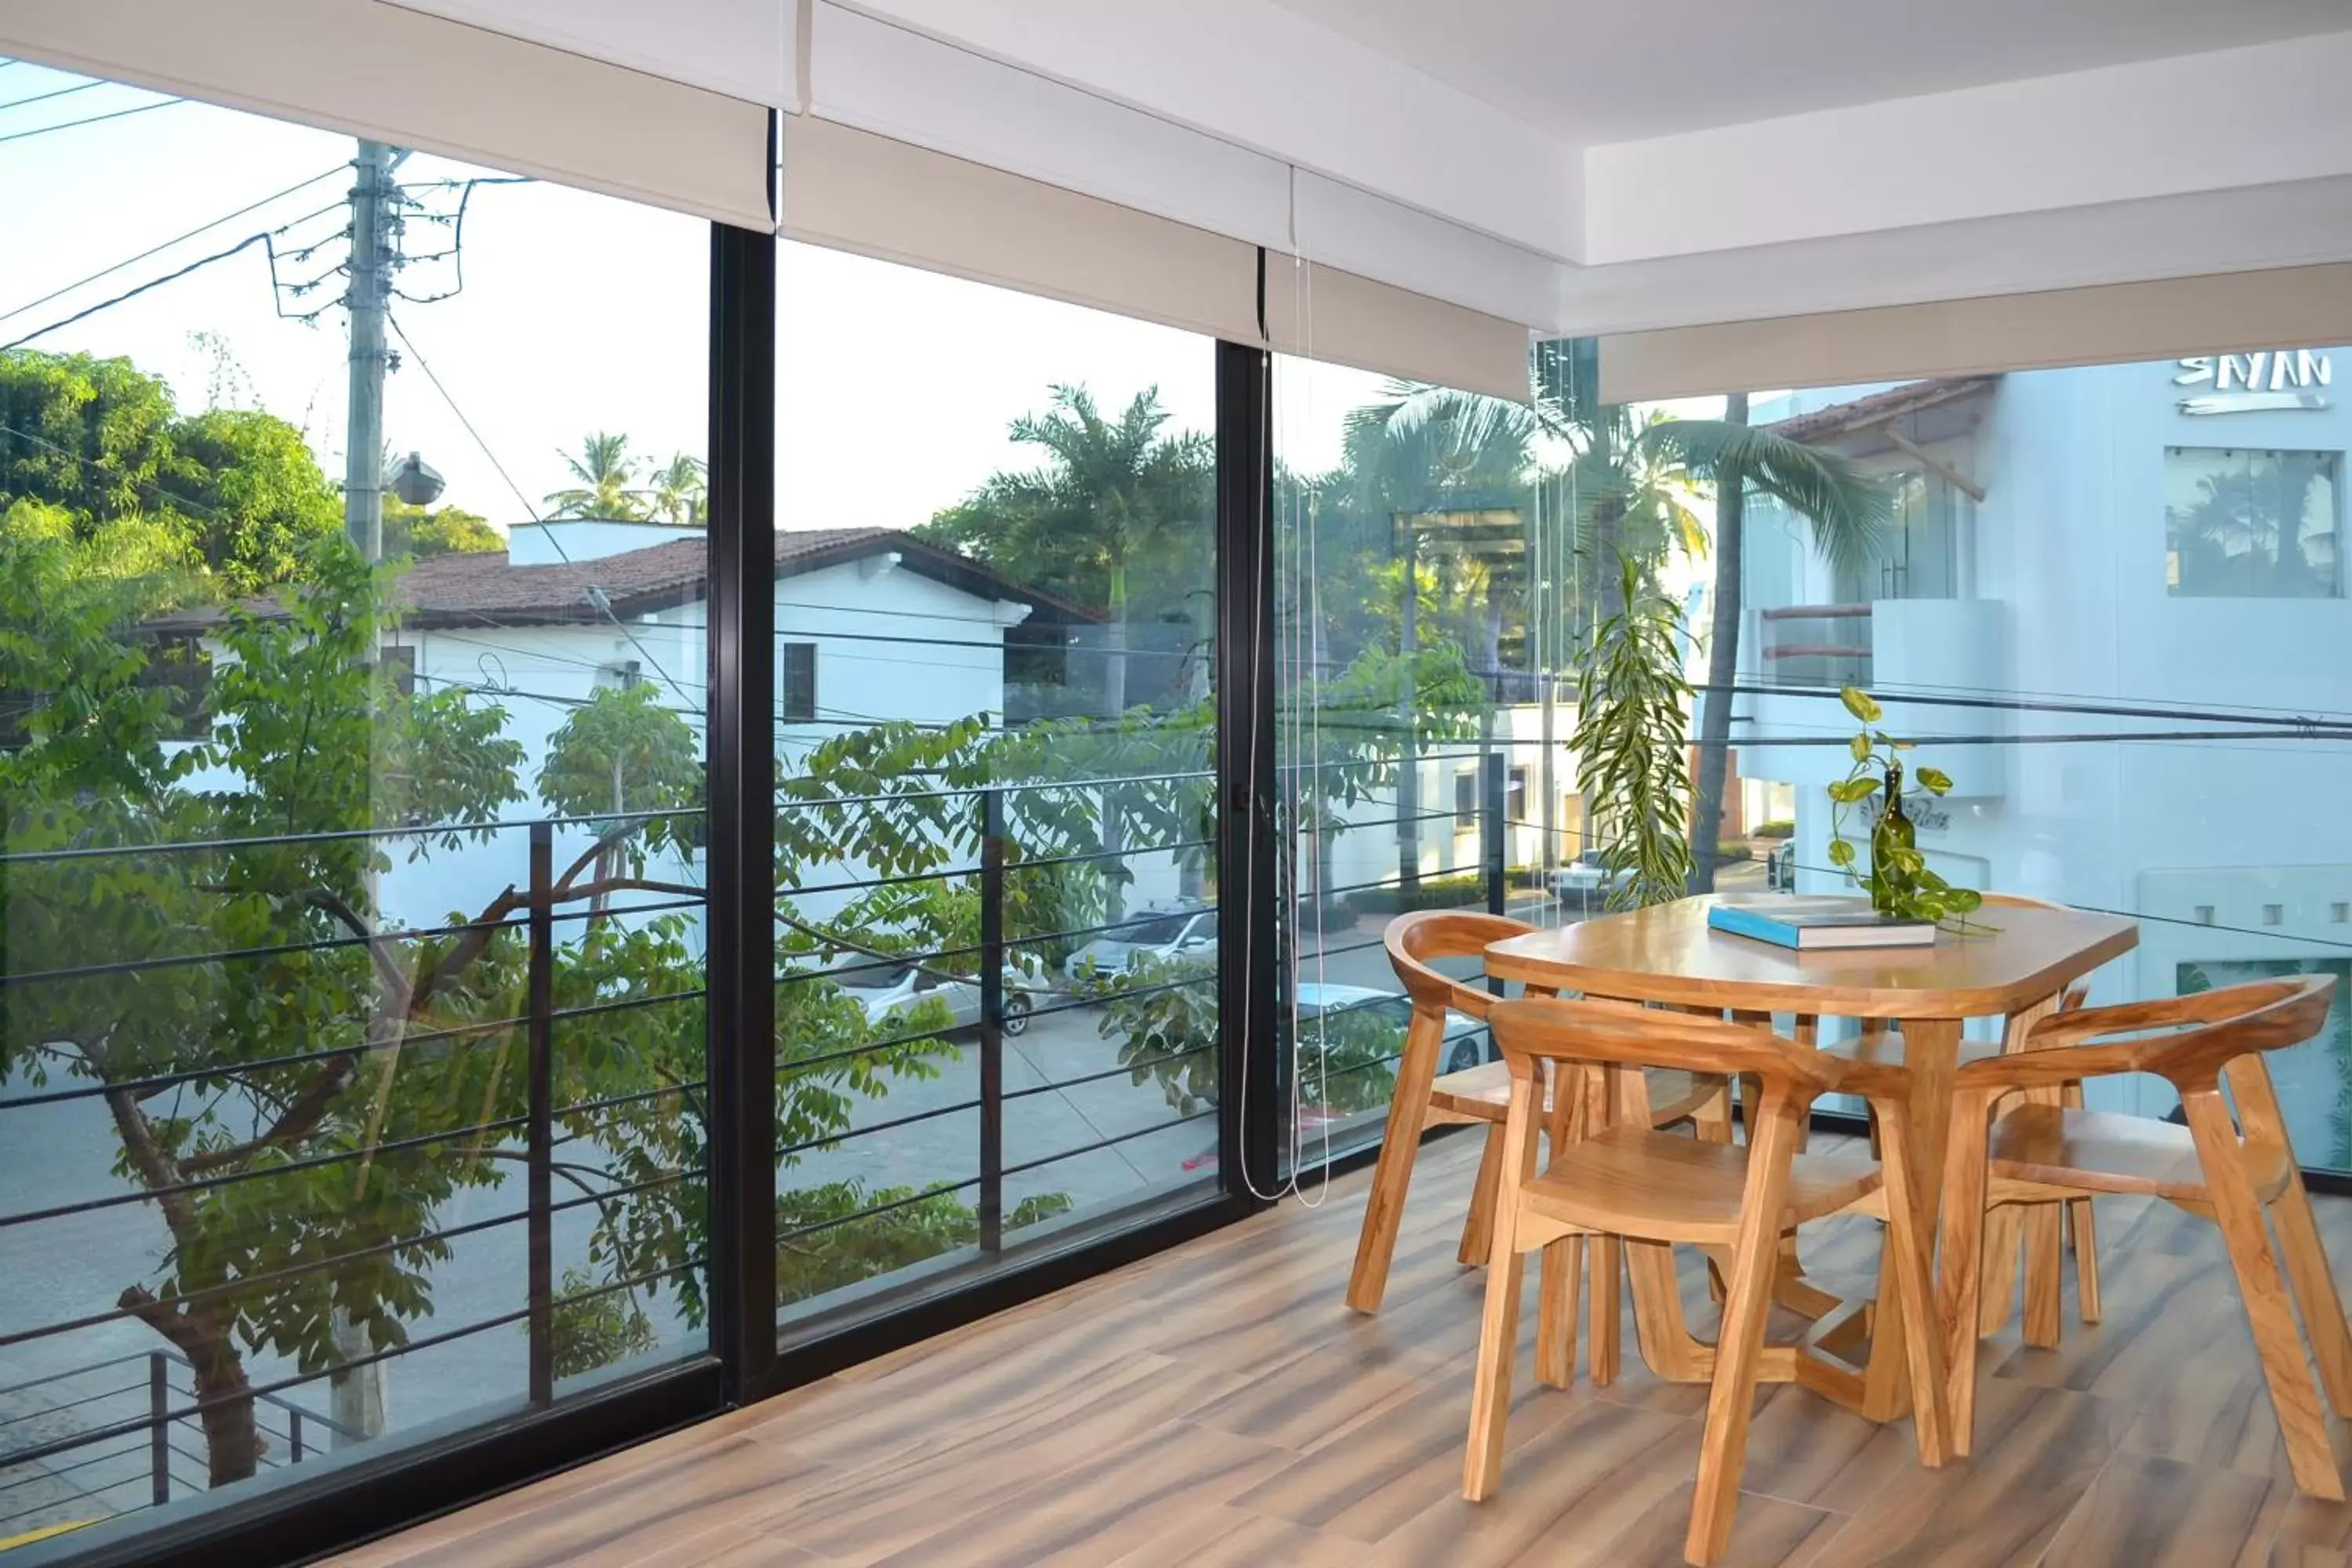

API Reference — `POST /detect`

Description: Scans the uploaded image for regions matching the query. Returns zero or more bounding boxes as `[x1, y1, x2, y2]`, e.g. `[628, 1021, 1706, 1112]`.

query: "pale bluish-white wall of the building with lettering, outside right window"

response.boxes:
[1740, 350, 2352, 1128]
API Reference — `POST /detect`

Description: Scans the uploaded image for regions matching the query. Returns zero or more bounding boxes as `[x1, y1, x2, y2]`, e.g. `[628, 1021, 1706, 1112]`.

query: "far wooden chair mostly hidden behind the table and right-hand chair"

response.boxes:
[1799, 893, 2100, 1349]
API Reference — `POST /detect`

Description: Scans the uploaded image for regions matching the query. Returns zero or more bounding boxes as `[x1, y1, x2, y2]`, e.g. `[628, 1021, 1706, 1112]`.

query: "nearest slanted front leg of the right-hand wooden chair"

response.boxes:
[2180, 1088, 2345, 1502]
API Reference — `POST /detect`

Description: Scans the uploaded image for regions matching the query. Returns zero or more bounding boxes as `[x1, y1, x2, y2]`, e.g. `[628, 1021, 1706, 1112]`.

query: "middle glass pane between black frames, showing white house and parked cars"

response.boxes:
[776, 245, 1218, 1340]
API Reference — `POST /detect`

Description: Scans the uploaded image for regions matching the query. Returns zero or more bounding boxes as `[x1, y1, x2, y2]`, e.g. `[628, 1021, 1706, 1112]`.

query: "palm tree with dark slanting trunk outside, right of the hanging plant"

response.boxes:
[1637, 393, 1893, 893]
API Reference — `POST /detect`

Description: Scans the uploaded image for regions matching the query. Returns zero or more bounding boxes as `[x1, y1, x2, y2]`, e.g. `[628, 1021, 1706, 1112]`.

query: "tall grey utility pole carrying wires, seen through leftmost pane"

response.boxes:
[327, 141, 400, 1448]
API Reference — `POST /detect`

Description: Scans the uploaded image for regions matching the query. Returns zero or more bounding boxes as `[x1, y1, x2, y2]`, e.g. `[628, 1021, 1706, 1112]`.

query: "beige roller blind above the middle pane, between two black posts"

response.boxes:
[783, 115, 1258, 341]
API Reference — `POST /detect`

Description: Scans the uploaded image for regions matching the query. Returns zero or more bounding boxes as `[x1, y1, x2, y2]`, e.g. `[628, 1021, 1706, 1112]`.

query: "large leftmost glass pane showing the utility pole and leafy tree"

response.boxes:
[0, 64, 708, 1537]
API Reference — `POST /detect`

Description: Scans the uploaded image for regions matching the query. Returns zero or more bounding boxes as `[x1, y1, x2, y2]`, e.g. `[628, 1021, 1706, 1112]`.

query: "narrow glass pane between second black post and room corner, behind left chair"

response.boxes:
[1275, 360, 1599, 1161]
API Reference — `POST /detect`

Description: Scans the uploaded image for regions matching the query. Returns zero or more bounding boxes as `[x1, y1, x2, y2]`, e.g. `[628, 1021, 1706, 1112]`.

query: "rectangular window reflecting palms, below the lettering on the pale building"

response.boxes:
[2164, 447, 2343, 600]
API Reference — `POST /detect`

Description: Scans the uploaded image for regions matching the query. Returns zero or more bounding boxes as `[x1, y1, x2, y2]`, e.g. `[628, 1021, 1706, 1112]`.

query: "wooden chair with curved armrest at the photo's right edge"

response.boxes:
[1940, 975, 2352, 1502]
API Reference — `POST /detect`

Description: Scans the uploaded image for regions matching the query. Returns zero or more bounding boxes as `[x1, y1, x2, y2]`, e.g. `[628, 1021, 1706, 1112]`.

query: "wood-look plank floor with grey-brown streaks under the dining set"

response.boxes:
[341, 1138, 2352, 1568]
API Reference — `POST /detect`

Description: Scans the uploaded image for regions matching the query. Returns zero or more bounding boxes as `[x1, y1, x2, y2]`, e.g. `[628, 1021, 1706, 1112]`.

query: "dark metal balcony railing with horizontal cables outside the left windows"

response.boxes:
[0, 769, 1216, 1537]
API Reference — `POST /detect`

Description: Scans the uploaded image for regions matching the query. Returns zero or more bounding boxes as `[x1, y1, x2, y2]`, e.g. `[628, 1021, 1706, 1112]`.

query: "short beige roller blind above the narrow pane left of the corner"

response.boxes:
[1265, 252, 1529, 402]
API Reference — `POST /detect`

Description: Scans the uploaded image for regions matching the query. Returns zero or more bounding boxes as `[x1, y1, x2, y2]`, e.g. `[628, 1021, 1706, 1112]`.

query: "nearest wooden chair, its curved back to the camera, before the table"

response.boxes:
[1463, 999, 1945, 1563]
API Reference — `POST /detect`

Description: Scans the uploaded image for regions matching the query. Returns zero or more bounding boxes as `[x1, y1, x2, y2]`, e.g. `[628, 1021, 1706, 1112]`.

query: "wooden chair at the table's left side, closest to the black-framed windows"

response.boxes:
[1348, 909, 1731, 1316]
